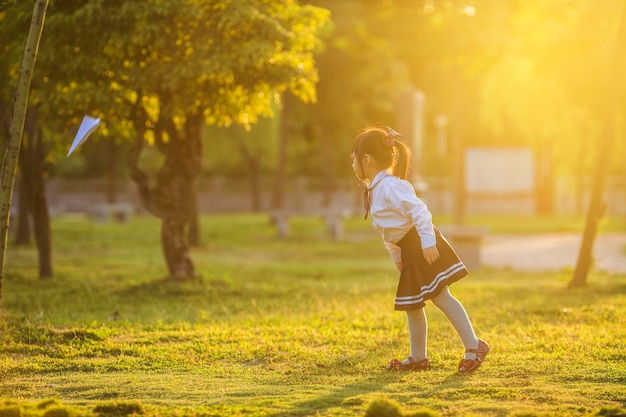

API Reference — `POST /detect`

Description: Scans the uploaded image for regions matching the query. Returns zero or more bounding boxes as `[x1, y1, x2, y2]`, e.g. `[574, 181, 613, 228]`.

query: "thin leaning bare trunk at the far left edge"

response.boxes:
[0, 0, 48, 306]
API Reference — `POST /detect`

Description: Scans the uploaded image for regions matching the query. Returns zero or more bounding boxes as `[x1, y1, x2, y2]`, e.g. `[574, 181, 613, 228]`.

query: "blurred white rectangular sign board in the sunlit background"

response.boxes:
[465, 148, 535, 194]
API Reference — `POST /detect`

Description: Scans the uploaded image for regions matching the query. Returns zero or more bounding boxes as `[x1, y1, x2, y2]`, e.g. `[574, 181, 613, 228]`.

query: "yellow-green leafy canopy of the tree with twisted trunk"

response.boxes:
[34, 0, 327, 124]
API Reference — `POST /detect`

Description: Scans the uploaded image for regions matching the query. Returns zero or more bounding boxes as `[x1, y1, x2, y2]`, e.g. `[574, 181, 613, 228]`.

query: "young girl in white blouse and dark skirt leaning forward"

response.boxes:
[352, 127, 489, 373]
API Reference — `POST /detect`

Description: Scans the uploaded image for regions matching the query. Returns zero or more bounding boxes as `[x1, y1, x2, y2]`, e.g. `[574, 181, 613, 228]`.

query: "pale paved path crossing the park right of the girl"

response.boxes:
[481, 232, 626, 274]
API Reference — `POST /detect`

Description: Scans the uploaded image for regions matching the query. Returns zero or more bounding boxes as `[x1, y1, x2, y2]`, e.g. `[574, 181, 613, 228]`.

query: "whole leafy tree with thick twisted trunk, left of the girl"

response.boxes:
[35, 0, 328, 279]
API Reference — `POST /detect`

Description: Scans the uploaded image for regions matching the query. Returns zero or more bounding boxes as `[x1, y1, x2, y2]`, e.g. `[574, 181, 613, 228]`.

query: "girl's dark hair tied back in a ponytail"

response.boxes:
[352, 127, 411, 179]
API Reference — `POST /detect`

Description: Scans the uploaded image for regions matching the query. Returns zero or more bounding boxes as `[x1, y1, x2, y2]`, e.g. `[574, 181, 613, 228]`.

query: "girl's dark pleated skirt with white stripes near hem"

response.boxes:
[395, 227, 468, 311]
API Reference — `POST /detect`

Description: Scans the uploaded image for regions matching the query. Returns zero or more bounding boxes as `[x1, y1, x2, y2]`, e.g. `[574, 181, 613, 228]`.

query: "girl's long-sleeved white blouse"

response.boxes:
[367, 170, 437, 263]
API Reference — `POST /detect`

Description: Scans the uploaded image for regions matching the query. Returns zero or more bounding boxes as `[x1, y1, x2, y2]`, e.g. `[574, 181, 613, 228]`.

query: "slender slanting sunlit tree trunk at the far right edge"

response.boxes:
[569, 5, 626, 287]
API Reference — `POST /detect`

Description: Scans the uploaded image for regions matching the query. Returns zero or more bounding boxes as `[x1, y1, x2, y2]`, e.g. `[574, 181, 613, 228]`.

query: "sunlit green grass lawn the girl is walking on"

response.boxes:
[0, 215, 626, 417]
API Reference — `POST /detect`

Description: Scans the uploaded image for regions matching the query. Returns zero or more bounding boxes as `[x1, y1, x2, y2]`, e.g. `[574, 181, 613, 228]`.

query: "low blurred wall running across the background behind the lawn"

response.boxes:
[13, 178, 626, 215]
